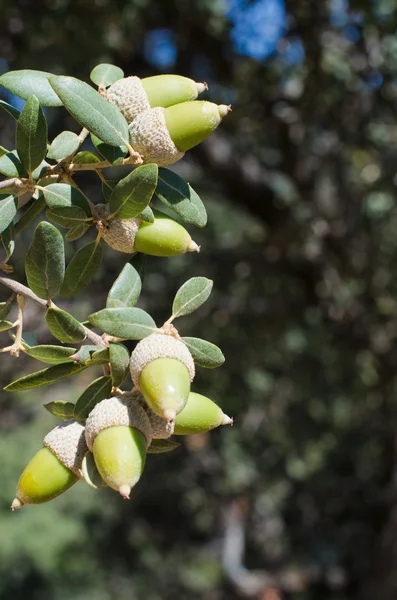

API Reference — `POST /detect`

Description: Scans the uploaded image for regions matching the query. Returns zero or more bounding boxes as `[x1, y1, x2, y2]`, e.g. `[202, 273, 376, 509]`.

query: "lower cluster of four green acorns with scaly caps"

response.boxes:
[11, 327, 233, 510]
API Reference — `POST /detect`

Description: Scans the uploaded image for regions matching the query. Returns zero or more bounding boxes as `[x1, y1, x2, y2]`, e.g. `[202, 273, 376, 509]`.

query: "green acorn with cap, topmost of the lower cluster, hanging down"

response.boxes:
[130, 333, 195, 421]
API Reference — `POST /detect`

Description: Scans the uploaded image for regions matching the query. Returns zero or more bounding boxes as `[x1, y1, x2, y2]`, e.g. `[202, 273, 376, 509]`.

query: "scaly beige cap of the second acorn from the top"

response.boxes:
[129, 104, 184, 167]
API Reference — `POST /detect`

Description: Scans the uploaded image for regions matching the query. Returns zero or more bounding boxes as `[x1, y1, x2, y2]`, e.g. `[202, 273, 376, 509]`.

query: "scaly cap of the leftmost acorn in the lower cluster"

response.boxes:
[43, 419, 88, 479]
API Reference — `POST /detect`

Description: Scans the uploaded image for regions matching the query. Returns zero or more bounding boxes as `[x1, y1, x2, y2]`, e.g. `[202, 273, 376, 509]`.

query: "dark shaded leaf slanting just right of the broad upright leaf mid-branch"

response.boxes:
[61, 242, 102, 296]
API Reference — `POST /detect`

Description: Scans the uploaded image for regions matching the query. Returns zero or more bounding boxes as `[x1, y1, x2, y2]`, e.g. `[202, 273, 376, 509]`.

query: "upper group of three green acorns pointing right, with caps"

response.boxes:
[94, 75, 230, 256]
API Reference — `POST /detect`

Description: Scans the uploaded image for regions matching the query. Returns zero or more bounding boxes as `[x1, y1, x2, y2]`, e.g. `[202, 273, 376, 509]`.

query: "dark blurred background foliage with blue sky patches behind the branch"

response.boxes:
[0, 0, 397, 600]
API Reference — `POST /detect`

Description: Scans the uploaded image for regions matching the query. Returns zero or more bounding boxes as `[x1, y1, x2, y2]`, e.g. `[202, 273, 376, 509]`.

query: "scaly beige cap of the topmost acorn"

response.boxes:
[105, 76, 150, 123]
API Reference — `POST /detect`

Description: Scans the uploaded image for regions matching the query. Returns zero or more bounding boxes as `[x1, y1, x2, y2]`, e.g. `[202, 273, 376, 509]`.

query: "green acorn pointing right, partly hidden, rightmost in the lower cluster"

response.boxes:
[173, 392, 233, 435]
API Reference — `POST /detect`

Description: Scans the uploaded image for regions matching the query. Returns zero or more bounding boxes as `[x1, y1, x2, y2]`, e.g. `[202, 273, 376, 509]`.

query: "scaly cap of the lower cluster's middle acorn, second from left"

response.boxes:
[85, 396, 152, 452]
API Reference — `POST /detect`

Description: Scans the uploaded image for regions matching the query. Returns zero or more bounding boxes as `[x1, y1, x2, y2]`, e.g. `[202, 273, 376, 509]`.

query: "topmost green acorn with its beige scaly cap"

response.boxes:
[105, 75, 207, 123]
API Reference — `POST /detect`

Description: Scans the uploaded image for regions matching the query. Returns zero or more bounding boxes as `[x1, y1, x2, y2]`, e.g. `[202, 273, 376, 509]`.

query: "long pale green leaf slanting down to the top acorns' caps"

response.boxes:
[49, 76, 129, 146]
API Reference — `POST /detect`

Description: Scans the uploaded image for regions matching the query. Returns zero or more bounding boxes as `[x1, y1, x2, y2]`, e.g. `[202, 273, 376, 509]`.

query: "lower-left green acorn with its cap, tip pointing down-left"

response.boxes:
[11, 419, 88, 510]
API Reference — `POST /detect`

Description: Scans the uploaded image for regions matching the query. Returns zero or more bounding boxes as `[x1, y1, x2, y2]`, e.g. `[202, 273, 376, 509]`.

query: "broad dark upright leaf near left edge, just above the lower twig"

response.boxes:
[24, 221, 65, 300]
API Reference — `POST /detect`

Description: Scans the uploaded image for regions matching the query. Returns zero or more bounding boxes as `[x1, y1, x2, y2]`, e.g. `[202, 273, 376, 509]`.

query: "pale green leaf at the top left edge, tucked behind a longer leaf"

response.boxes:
[0, 69, 62, 106]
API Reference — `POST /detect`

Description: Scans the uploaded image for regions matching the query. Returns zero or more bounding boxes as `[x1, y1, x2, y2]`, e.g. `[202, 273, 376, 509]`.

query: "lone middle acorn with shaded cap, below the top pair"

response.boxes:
[95, 205, 200, 256]
